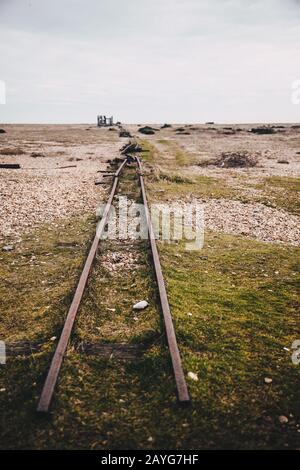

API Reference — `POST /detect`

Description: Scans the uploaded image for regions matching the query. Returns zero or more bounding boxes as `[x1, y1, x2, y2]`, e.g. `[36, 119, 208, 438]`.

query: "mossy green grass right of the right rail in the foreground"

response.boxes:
[160, 233, 300, 448]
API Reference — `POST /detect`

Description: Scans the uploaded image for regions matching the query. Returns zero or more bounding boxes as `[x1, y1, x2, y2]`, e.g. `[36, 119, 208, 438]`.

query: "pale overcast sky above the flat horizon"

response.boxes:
[0, 0, 300, 123]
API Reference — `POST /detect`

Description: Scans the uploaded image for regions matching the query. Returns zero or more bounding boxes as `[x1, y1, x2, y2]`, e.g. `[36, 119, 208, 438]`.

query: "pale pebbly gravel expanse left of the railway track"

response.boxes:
[0, 125, 120, 241]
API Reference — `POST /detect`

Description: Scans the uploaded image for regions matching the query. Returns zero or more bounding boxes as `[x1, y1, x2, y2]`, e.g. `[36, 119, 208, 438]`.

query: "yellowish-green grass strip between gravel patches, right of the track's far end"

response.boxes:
[141, 140, 300, 215]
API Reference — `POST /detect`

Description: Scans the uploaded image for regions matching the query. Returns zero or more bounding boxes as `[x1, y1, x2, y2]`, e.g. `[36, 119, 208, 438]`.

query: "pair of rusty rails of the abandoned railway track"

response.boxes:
[37, 146, 190, 413]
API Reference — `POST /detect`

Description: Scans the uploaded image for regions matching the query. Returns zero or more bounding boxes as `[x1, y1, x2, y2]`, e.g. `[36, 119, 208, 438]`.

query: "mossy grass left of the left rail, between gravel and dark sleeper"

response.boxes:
[0, 216, 95, 341]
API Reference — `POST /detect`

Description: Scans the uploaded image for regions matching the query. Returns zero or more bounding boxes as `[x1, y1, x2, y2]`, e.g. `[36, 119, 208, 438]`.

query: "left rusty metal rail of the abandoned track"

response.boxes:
[37, 159, 127, 413]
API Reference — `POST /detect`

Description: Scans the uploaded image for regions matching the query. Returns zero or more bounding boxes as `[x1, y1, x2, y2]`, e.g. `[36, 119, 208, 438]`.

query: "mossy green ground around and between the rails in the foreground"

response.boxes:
[0, 145, 300, 449]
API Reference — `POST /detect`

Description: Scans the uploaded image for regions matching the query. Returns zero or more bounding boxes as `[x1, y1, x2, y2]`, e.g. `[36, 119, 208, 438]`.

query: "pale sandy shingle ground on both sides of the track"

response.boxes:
[0, 124, 300, 245]
